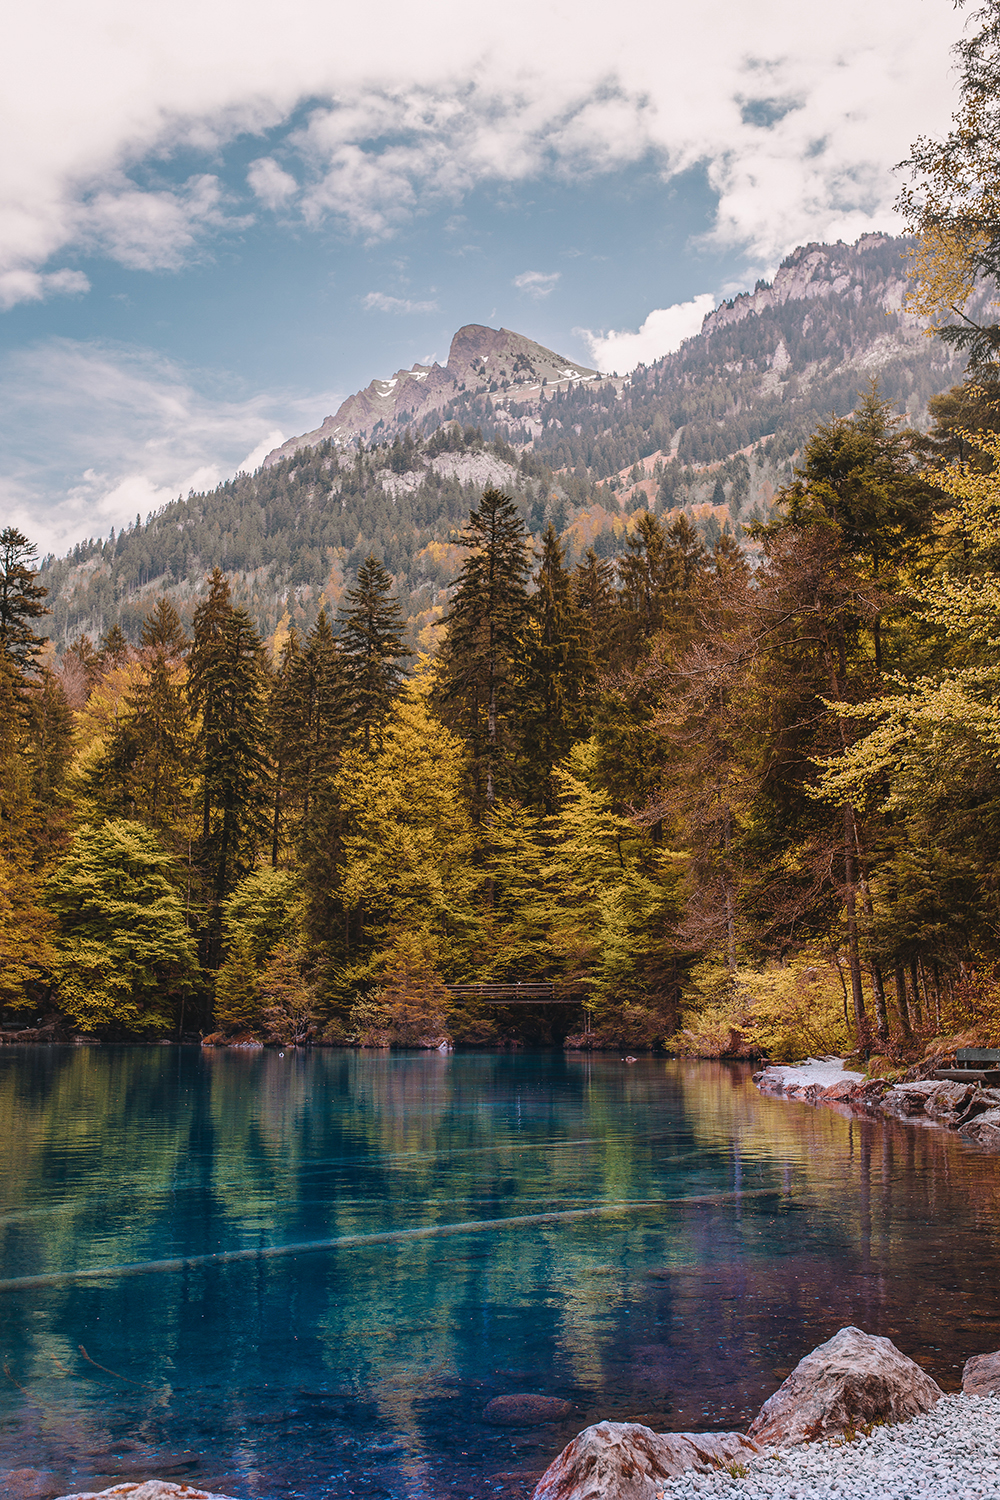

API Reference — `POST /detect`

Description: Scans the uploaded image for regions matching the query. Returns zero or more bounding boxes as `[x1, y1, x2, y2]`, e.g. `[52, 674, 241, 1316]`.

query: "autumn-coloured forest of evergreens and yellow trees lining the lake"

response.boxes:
[0, 364, 1000, 1067]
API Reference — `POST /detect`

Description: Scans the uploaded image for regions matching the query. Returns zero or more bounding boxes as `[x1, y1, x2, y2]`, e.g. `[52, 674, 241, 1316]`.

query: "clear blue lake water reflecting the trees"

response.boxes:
[0, 1047, 1000, 1500]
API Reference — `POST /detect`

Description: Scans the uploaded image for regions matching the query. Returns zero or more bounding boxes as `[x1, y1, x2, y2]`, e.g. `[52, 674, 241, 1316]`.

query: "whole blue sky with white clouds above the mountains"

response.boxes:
[0, 0, 966, 554]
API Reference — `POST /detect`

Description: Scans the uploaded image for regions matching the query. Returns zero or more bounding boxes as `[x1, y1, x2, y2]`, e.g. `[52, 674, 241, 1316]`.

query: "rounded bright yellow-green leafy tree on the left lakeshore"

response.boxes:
[45, 819, 198, 1032]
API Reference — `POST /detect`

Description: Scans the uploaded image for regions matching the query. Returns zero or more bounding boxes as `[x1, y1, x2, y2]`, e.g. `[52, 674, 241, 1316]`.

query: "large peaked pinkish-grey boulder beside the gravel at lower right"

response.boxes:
[748, 1328, 942, 1448]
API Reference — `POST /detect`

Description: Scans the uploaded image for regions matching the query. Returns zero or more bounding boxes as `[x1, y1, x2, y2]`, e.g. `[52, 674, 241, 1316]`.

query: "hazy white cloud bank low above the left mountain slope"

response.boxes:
[0, 339, 343, 552]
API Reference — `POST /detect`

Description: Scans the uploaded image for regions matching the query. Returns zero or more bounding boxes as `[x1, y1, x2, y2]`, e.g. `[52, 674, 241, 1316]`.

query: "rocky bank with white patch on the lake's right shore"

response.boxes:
[754, 1058, 1000, 1146]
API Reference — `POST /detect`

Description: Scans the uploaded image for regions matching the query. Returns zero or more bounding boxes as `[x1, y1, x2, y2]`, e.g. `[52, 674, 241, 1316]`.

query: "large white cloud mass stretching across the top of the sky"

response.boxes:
[0, 0, 963, 297]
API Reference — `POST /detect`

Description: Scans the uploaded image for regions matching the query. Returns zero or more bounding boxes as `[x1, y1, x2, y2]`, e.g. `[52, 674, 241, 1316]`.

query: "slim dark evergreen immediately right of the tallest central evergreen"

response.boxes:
[520, 524, 597, 813]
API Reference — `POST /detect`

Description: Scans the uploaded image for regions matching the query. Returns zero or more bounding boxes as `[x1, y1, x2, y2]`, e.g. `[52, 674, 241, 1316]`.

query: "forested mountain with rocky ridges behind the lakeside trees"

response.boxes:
[40, 236, 963, 647]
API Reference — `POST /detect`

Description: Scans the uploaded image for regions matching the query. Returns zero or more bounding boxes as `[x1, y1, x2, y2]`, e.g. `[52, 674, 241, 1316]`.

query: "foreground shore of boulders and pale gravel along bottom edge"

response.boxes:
[25, 1328, 1000, 1500]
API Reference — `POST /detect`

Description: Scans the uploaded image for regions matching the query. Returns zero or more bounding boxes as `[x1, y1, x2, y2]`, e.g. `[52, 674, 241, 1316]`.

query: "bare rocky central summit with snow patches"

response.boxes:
[264, 323, 598, 468]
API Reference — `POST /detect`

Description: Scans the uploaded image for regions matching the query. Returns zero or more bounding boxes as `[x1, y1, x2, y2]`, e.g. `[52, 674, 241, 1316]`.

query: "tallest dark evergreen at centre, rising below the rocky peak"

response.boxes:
[438, 489, 529, 819]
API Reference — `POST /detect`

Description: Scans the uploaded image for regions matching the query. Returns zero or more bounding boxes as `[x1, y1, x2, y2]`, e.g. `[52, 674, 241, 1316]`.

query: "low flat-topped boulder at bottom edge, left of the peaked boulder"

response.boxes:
[531, 1422, 757, 1500]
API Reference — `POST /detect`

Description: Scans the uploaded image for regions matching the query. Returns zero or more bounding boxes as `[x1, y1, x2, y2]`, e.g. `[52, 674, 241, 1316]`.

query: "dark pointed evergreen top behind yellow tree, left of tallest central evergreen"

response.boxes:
[340, 555, 412, 750]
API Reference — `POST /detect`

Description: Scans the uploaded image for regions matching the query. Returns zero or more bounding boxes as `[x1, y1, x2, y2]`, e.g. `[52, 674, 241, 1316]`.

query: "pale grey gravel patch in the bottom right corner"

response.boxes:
[657, 1395, 1000, 1500]
